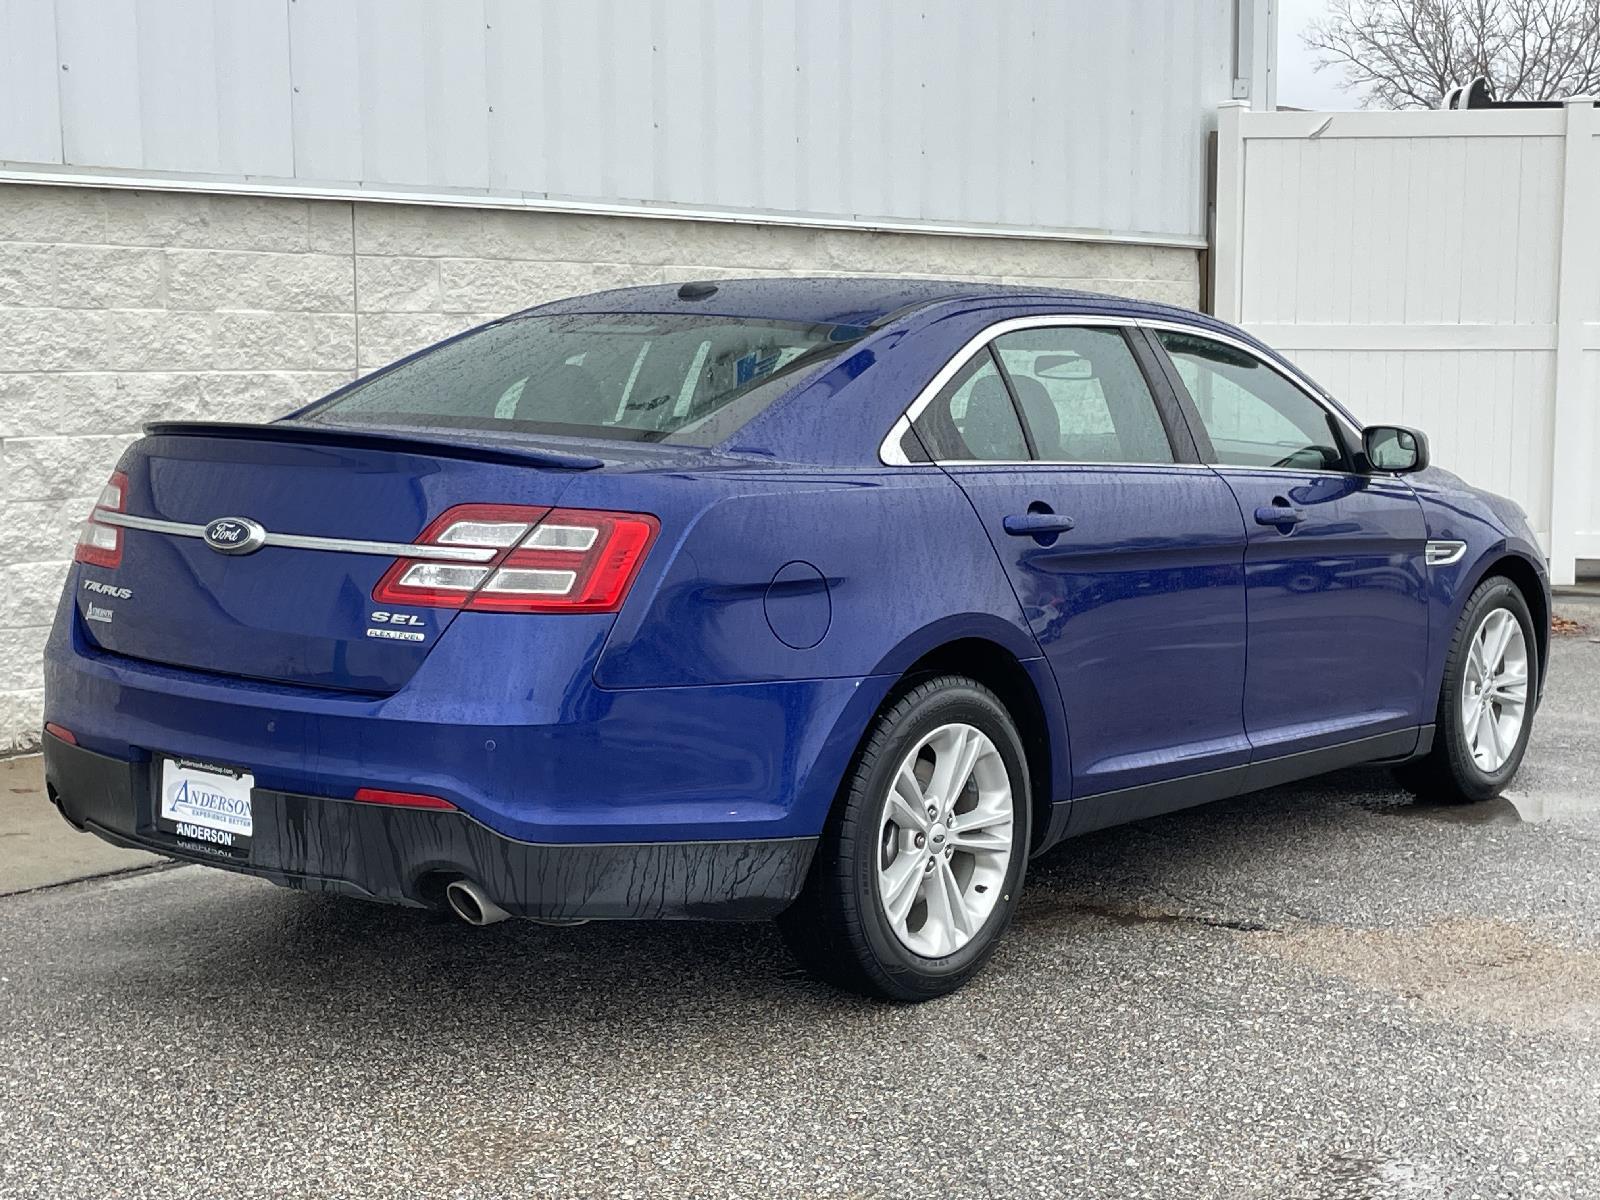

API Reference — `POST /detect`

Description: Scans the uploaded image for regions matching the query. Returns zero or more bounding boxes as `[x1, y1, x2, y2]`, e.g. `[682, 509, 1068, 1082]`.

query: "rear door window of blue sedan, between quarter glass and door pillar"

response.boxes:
[994, 325, 1173, 462]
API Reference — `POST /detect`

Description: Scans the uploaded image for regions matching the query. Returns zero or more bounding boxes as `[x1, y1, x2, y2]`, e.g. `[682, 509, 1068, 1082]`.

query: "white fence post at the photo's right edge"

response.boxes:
[1550, 96, 1600, 584]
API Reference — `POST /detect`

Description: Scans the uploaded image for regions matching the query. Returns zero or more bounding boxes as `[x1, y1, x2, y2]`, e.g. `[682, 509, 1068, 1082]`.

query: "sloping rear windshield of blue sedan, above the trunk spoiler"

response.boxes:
[299, 314, 866, 446]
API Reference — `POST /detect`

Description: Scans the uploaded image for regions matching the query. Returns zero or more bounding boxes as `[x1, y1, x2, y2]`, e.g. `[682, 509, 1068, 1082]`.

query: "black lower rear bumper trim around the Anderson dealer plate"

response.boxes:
[45, 734, 818, 920]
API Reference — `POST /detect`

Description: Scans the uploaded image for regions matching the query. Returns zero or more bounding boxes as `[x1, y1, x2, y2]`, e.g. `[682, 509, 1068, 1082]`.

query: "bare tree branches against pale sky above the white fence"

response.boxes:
[1302, 0, 1600, 109]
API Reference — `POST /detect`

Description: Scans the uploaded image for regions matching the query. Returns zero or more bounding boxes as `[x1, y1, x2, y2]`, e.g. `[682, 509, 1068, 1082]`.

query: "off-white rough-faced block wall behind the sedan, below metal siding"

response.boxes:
[0, 184, 1198, 754]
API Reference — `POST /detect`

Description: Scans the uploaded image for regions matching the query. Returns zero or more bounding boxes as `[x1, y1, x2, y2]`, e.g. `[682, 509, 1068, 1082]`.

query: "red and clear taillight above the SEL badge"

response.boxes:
[373, 504, 661, 613]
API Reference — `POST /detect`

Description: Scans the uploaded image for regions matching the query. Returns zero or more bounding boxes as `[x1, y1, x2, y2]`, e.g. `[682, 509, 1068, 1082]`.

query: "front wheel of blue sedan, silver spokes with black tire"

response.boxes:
[1395, 574, 1539, 803]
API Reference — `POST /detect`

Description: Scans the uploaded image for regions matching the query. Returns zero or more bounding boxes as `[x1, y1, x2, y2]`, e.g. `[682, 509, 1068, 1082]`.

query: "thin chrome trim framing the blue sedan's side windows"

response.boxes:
[878, 312, 1362, 475]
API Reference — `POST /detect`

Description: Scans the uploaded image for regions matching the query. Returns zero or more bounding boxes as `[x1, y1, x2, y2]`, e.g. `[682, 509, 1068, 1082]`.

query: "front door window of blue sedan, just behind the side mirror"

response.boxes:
[1155, 330, 1349, 470]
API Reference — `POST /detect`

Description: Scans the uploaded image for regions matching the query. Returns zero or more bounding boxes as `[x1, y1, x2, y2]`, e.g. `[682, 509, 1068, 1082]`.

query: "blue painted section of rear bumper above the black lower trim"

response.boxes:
[43, 606, 893, 846]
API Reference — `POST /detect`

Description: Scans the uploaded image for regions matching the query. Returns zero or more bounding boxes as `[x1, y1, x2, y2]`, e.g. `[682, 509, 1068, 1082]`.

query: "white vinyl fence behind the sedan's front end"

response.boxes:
[1211, 98, 1600, 584]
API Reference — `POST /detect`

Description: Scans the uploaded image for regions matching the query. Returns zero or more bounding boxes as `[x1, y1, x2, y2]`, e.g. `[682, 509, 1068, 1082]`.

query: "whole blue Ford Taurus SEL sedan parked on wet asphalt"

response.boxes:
[45, 280, 1550, 1000]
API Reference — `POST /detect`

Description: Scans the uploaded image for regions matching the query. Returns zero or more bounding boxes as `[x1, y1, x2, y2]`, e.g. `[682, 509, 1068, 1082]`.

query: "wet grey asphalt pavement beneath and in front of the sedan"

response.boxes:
[0, 624, 1600, 1200]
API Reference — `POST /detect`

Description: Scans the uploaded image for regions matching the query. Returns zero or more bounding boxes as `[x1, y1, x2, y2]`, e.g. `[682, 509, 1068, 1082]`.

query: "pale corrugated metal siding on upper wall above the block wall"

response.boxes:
[0, 0, 1235, 240]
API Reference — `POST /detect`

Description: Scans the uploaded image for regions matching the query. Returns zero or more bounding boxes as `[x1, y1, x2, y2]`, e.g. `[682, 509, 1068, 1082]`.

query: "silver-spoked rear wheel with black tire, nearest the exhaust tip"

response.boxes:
[778, 675, 1032, 1002]
